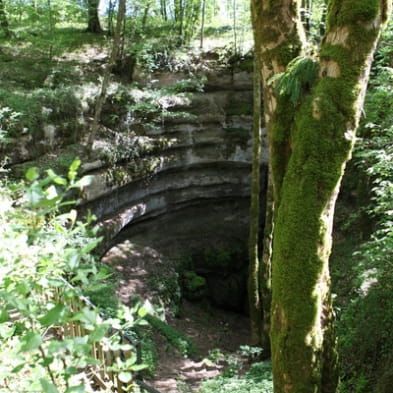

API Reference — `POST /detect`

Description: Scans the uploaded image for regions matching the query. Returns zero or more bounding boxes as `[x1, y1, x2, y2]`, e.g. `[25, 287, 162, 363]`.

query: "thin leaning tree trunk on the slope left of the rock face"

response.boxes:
[88, 0, 126, 154]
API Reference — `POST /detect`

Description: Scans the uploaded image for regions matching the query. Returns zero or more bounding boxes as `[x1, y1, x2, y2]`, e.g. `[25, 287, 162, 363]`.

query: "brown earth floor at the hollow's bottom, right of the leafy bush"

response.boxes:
[151, 301, 249, 393]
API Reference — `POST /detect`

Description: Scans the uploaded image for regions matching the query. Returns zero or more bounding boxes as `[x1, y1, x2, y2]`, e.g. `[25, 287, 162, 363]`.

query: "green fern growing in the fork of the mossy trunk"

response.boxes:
[269, 56, 318, 104]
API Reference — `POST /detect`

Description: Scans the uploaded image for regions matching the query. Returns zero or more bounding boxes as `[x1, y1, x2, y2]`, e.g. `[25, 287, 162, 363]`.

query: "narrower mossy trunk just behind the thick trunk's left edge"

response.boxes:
[251, 0, 303, 356]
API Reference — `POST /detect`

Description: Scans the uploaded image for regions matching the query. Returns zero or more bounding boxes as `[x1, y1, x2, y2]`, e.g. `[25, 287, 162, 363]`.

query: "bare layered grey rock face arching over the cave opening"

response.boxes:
[84, 65, 267, 255]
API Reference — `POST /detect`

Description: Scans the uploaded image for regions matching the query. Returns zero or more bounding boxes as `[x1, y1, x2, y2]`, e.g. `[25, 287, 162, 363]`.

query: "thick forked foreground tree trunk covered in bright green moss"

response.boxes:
[253, 0, 391, 393]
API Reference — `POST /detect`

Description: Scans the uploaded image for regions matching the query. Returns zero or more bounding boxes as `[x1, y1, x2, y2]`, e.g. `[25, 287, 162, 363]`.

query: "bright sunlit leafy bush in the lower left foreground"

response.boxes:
[0, 160, 146, 393]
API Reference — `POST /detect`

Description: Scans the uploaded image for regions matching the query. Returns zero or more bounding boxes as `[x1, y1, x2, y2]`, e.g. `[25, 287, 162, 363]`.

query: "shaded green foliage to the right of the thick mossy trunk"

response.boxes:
[339, 20, 393, 393]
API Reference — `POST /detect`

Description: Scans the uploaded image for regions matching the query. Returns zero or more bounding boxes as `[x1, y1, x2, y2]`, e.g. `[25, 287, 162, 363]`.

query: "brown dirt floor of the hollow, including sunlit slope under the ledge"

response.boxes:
[103, 240, 249, 393]
